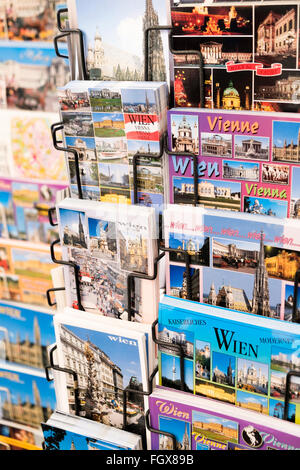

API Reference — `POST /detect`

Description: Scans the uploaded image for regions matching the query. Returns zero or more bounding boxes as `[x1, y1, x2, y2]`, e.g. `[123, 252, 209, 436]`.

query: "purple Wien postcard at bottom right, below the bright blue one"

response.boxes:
[149, 388, 300, 451]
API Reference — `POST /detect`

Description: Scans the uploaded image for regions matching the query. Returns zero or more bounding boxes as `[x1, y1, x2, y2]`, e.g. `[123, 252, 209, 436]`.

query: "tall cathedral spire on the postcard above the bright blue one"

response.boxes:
[251, 232, 272, 317]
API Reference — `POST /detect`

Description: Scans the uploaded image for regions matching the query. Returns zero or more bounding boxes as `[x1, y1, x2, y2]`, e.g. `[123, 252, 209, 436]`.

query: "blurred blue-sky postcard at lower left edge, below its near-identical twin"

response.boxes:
[0, 363, 56, 430]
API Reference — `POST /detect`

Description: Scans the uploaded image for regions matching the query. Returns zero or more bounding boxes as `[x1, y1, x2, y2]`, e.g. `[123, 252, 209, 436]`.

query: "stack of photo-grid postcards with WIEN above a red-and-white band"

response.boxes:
[59, 81, 167, 210]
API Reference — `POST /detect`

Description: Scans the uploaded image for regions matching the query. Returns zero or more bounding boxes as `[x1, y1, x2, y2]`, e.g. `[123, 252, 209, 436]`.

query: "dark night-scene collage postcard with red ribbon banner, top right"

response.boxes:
[168, 0, 300, 112]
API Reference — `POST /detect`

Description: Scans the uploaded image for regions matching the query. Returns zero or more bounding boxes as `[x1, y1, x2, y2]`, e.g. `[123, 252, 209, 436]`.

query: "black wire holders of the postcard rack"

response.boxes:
[46, 8, 300, 449]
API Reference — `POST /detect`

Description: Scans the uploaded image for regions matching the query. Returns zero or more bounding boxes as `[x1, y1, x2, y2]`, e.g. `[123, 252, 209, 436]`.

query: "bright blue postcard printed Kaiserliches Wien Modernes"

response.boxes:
[158, 296, 300, 424]
